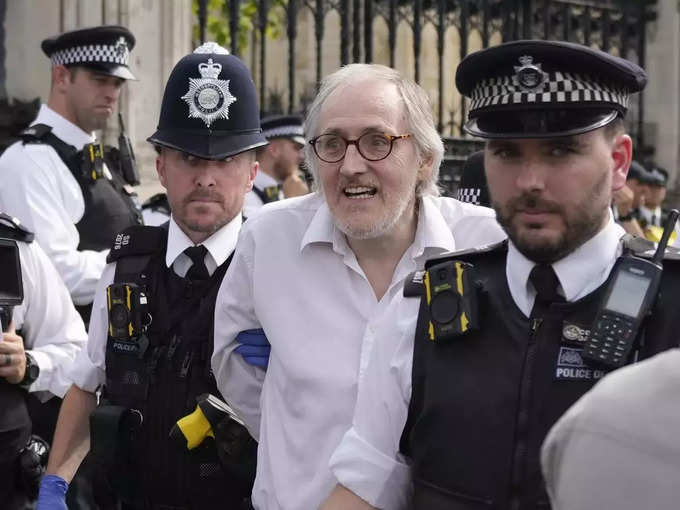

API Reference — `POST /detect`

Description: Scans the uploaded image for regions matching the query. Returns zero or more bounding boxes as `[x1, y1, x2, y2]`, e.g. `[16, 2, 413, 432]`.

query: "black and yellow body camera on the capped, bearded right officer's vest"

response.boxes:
[423, 260, 479, 341]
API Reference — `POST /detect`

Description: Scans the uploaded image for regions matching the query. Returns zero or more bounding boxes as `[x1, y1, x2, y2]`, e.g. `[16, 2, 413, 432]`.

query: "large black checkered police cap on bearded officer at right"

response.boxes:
[456, 40, 647, 138]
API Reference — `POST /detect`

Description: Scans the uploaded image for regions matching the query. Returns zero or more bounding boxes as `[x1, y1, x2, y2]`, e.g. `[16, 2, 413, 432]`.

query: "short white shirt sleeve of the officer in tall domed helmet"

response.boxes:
[70, 263, 116, 393]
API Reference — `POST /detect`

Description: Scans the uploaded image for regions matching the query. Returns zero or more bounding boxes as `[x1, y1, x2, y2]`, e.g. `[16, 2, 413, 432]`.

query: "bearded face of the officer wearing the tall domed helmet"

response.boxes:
[156, 148, 257, 243]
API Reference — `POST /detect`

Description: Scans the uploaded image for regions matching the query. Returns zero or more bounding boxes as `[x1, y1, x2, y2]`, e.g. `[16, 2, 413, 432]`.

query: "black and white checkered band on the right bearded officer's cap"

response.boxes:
[470, 71, 629, 113]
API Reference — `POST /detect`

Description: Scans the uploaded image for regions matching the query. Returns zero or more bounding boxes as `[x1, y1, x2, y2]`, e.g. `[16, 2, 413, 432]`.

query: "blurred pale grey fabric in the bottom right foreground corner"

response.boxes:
[541, 349, 680, 510]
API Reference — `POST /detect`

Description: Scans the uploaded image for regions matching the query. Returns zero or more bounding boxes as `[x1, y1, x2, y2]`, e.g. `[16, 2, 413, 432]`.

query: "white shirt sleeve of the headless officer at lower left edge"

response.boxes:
[5, 242, 87, 401]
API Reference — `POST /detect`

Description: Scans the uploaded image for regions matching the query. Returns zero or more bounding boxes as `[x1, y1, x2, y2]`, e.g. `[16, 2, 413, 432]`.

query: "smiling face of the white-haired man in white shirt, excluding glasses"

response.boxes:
[318, 80, 429, 239]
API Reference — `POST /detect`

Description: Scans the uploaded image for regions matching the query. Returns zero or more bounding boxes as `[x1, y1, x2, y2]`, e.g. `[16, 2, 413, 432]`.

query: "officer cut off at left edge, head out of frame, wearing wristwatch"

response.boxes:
[0, 214, 87, 510]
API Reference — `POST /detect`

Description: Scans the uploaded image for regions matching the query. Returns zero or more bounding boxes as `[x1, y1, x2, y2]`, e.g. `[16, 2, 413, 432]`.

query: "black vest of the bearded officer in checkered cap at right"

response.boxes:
[400, 248, 680, 510]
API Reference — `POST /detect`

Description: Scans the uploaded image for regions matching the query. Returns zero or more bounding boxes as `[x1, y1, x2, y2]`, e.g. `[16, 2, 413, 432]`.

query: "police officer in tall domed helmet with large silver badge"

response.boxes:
[39, 43, 267, 509]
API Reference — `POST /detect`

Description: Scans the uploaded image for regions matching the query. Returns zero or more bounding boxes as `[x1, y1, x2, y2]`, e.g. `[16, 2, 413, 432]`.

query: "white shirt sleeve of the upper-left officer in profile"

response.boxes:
[0, 146, 108, 305]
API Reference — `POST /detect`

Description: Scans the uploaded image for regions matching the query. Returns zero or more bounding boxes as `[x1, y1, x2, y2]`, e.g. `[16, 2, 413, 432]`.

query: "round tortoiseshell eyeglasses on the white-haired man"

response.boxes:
[309, 133, 411, 163]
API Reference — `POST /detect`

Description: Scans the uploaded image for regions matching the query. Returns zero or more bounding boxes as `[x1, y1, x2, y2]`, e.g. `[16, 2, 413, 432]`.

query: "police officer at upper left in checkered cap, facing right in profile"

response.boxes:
[0, 26, 140, 316]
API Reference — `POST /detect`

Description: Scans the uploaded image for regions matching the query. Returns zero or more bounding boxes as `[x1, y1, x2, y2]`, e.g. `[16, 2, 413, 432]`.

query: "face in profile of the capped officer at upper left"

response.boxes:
[63, 67, 125, 133]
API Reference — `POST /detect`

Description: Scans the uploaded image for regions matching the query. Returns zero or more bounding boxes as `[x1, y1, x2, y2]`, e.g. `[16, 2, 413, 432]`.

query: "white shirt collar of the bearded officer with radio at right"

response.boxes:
[506, 214, 625, 317]
